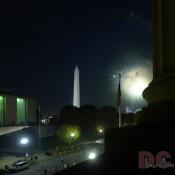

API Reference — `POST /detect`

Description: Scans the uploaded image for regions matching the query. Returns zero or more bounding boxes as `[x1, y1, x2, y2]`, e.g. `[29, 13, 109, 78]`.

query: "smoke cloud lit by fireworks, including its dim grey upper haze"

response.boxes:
[110, 53, 153, 112]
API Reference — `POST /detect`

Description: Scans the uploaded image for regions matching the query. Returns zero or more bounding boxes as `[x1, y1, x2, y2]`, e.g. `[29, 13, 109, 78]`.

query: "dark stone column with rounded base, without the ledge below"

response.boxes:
[141, 0, 175, 123]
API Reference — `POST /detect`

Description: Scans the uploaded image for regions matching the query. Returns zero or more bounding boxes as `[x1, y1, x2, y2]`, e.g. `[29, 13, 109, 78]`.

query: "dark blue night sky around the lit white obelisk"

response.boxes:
[0, 0, 152, 114]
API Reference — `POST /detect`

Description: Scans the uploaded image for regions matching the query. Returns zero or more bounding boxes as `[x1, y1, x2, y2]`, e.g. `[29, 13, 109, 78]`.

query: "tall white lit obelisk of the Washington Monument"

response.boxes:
[73, 66, 80, 108]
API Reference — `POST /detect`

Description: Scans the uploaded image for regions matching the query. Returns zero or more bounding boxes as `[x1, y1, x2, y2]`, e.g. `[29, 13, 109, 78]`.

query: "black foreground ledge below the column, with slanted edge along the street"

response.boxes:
[55, 126, 175, 175]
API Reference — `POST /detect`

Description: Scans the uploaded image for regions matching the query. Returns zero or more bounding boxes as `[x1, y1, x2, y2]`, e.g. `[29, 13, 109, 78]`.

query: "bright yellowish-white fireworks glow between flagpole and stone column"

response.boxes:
[113, 65, 152, 112]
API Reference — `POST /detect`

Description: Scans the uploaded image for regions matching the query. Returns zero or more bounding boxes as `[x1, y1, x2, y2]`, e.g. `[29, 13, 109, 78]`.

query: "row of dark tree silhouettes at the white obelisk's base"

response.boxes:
[59, 104, 133, 138]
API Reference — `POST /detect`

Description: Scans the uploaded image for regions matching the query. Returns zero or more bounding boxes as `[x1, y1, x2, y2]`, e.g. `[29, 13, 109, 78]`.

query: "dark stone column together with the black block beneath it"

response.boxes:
[105, 0, 175, 174]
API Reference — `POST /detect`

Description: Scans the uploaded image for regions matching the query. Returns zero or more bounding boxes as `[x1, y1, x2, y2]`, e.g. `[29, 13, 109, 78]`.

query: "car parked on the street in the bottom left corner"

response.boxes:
[9, 160, 29, 173]
